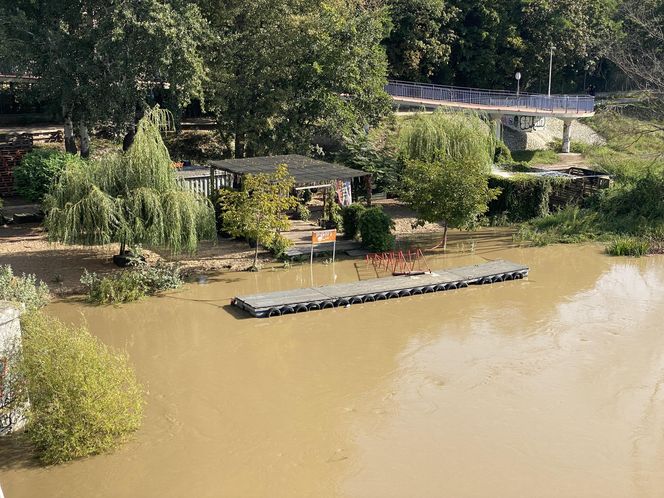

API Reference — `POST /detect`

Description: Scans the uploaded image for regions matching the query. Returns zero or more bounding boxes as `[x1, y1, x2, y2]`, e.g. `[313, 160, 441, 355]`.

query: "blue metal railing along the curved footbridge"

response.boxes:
[385, 80, 595, 114]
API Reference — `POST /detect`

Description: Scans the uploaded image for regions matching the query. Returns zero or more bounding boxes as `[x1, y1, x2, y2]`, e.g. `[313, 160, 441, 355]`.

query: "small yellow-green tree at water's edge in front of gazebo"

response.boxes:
[223, 164, 297, 269]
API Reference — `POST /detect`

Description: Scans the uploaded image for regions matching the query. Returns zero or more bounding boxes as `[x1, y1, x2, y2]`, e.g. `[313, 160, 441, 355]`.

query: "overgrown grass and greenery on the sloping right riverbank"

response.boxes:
[517, 112, 664, 256]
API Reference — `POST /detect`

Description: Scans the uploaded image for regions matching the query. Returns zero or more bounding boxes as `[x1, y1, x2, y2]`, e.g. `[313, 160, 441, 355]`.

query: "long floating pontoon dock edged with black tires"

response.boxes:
[231, 260, 528, 318]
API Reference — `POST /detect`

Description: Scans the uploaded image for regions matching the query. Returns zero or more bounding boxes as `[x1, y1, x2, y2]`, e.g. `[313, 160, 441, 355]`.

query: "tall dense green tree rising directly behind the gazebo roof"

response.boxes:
[200, 0, 390, 157]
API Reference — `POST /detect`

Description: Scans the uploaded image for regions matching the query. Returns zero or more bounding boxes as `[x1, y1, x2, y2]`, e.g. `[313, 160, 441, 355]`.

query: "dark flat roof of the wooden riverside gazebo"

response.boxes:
[210, 154, 369, 185]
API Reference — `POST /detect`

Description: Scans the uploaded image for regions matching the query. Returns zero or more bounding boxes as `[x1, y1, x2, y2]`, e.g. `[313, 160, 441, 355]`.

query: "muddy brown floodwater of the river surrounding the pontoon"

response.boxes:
[0, 240, 664, 498]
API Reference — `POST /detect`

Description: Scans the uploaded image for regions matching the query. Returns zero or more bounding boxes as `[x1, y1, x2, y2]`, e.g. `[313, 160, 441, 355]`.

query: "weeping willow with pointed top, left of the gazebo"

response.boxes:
[44, 107, 215, 255]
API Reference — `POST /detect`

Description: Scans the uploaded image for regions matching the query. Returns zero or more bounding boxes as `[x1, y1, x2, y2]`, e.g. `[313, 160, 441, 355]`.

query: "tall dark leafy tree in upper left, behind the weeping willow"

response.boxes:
[0, 0, 207, 156]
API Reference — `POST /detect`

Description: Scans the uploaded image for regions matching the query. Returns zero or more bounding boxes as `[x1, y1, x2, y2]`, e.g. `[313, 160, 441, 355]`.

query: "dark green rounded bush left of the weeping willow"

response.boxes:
[14, 149, 83, 202]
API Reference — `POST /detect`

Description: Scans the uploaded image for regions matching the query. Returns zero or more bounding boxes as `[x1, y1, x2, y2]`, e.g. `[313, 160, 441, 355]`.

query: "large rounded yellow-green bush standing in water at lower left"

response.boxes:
[18, 312, 143, 464]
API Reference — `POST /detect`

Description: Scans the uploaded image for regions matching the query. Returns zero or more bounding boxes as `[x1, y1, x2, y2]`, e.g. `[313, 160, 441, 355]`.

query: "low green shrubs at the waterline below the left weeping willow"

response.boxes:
[81, 263, 182, 304]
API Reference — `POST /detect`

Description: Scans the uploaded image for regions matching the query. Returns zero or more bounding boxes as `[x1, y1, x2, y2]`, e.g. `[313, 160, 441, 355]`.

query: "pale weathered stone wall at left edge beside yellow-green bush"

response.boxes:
[0, 301, 25, 436]
